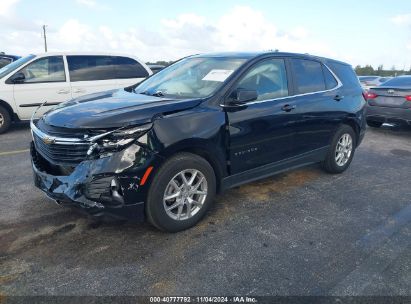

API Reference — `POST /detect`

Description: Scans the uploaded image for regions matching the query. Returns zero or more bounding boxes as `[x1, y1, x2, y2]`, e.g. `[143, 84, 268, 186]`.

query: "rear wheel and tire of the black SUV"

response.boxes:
[322, 125, 357, 174]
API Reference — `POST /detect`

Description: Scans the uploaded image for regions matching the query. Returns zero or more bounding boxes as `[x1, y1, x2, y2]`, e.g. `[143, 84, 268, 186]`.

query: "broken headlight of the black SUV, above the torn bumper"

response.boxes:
[87, 123, 153, 155]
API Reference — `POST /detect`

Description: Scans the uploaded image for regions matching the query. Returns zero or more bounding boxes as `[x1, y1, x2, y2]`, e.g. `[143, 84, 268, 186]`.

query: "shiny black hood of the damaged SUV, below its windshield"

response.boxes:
[43, 89, 202, 129]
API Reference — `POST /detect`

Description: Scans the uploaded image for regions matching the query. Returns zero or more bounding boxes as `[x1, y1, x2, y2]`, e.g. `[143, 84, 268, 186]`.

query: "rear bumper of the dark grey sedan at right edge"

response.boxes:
[366, 105, 411, 125]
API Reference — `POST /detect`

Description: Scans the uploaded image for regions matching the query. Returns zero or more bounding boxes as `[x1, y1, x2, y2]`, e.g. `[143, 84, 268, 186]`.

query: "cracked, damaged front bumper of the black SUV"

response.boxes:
[31, 143, 158, 221]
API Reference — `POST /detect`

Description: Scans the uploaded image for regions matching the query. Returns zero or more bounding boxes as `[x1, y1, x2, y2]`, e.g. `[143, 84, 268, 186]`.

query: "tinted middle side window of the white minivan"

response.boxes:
[67, 55, 117, 82]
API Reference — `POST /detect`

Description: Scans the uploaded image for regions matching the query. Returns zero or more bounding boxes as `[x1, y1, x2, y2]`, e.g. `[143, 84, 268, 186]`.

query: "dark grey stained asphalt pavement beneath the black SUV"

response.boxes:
[0, 124, 411, 299]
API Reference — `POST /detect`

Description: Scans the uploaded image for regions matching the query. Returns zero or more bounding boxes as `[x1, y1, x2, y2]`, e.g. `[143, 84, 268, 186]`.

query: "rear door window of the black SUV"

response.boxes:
[291, 59, 325, 94]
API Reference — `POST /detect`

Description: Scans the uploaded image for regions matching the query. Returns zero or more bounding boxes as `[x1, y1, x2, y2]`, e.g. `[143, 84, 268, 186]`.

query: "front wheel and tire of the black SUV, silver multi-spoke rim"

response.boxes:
[146, 153, 216, 232]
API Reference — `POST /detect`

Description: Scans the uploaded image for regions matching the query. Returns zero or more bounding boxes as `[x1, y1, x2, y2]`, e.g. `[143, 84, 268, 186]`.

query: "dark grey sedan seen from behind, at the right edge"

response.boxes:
[366, 76, 411, 128]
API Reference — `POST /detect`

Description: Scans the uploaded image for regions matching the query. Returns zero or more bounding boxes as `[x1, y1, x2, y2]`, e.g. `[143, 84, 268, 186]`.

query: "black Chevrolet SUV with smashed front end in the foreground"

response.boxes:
[31, 52, 365, 231]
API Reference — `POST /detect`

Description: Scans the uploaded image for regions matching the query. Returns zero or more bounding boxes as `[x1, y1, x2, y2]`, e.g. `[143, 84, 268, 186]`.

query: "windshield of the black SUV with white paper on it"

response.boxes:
[135, 57, 246, 98]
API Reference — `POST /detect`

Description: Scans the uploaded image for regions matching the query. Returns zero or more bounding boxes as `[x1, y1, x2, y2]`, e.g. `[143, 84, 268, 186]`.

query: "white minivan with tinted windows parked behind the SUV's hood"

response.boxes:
[0, 53, 152, 133]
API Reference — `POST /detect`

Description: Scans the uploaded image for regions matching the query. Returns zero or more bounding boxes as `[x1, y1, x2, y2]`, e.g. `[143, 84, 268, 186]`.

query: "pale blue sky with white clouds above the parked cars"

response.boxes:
[0, 0, 411, 70]
